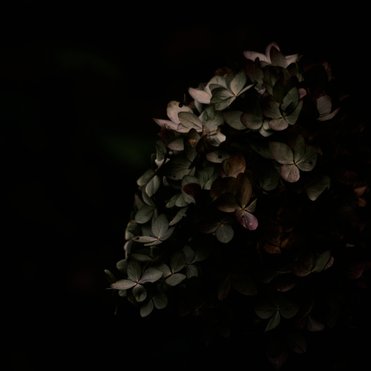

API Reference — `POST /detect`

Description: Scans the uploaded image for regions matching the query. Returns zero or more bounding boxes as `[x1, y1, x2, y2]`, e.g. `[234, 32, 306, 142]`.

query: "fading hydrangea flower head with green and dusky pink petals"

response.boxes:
[107, 43, 371, 370]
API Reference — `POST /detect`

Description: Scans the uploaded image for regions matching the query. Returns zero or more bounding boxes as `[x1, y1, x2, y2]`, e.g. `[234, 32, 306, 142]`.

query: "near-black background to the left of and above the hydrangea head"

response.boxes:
[0, 1, 369, 370]
